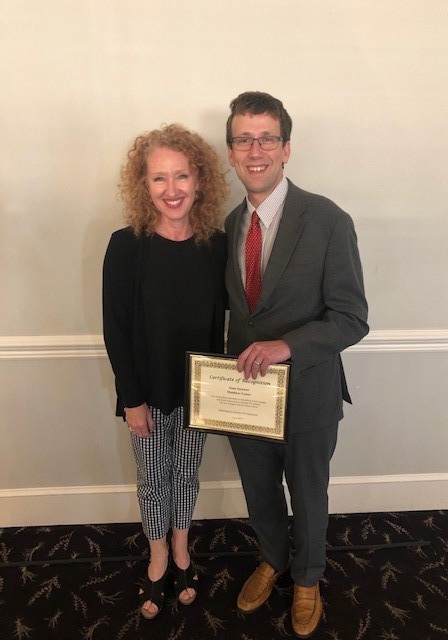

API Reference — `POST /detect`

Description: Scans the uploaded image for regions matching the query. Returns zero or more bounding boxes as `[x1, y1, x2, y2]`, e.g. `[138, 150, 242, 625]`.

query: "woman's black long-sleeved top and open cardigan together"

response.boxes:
[103, 228, 227, 415]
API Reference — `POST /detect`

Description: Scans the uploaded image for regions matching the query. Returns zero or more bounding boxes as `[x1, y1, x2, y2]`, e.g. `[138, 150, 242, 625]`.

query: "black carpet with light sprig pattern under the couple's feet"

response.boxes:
[0, 511, 448, 640]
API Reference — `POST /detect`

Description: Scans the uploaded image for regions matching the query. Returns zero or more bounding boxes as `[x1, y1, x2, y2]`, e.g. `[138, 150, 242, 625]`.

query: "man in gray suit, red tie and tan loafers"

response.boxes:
[226, 92, 368, 638]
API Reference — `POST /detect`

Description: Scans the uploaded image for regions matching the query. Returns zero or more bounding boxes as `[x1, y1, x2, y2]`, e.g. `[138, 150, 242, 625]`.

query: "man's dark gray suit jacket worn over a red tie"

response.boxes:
[226, 182, 369, 433]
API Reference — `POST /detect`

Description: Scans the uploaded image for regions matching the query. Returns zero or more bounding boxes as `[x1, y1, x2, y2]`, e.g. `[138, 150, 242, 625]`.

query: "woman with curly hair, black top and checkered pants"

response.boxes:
[103, 124, 227, 619]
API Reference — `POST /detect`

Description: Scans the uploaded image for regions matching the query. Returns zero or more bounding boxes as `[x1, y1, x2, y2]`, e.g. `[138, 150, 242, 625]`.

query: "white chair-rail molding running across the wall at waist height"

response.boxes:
[0, 329, 448, 360]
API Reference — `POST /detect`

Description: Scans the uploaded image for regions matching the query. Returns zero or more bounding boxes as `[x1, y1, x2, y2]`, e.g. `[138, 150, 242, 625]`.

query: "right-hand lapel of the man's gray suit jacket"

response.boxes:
[257, 182, 305, 308]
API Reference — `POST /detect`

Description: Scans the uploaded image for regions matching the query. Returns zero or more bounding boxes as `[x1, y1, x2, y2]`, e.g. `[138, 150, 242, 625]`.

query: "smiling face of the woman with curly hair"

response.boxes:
[146, 147, 198, 226]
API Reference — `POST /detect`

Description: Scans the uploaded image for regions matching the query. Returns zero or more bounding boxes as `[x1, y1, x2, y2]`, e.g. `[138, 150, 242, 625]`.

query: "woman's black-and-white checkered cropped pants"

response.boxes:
[131, 407, 206, 540]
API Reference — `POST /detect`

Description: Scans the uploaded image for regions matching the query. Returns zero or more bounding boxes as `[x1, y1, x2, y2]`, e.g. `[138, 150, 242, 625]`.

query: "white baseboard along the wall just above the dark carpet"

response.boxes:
[0, 473, 448, 527]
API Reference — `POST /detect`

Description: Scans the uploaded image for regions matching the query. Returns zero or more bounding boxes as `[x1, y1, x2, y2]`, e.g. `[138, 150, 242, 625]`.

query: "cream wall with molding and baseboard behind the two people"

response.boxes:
[0, 0, 448, 526]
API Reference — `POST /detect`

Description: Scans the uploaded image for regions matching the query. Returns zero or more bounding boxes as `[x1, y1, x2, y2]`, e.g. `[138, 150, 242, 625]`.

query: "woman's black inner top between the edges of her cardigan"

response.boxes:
[142, 235, 215, 412]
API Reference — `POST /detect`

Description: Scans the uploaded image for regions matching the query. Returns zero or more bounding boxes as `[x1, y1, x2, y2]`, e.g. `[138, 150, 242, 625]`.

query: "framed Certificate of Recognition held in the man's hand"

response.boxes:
[184, 351, 290, 442]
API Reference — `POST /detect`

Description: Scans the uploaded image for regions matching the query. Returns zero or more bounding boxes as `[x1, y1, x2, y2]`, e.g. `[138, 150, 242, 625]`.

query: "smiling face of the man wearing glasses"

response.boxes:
[227, 113, 290, 207]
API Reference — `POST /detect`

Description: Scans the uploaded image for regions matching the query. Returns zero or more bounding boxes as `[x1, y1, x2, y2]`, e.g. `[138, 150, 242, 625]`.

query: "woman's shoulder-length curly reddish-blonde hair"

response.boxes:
[119, 124, 228, 242]
